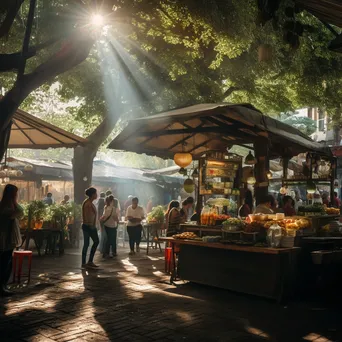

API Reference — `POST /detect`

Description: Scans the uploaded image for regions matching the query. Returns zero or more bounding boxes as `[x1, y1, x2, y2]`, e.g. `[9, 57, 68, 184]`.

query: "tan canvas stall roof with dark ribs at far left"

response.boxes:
[8, 109, 86, 149]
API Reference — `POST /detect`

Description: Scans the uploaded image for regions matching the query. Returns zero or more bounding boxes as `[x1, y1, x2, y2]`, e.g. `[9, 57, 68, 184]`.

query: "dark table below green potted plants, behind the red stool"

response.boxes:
[23, 228, 64, 256]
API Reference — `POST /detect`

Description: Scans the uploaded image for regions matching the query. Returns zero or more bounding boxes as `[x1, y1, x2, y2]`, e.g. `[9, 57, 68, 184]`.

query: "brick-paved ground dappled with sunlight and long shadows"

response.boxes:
[0, 249, 342, 342]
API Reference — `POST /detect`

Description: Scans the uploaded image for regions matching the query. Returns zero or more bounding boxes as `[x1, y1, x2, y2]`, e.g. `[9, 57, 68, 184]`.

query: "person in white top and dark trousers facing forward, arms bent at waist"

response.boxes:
[126, 197, 145, 255]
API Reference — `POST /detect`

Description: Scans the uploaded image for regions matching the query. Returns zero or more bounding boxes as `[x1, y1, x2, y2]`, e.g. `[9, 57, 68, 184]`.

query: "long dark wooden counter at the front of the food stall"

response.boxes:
[159, 238, 300, 302]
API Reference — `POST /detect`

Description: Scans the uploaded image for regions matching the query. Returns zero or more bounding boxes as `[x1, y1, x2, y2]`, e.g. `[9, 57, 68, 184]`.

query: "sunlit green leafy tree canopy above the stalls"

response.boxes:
[0, 0, 342, 154]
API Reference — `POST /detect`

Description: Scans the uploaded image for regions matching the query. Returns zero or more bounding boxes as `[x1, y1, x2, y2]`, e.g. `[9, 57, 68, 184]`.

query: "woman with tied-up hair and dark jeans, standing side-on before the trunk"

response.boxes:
[82, 188, 99, 268]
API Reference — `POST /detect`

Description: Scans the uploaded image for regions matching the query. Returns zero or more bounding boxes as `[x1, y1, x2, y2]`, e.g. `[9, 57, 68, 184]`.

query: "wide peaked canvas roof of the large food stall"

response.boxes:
[108, 103, 332, 159]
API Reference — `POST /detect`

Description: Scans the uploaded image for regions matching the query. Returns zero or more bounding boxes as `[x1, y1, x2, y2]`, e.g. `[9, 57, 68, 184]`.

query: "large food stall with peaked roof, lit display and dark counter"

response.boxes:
[109, 104, 339, 300]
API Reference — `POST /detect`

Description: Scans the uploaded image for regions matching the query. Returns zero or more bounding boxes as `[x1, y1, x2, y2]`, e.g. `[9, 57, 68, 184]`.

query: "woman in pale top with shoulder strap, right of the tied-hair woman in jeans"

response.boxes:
[100, 195, 120, 258]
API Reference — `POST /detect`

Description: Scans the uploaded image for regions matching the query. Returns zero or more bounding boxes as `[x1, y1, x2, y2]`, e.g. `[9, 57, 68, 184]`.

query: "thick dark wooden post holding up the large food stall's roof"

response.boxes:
[254, 139, 269, 205]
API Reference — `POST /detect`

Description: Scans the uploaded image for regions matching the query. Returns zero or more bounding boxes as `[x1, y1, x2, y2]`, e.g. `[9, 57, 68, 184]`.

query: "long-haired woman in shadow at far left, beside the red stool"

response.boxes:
[0, 184, 23, 297]
